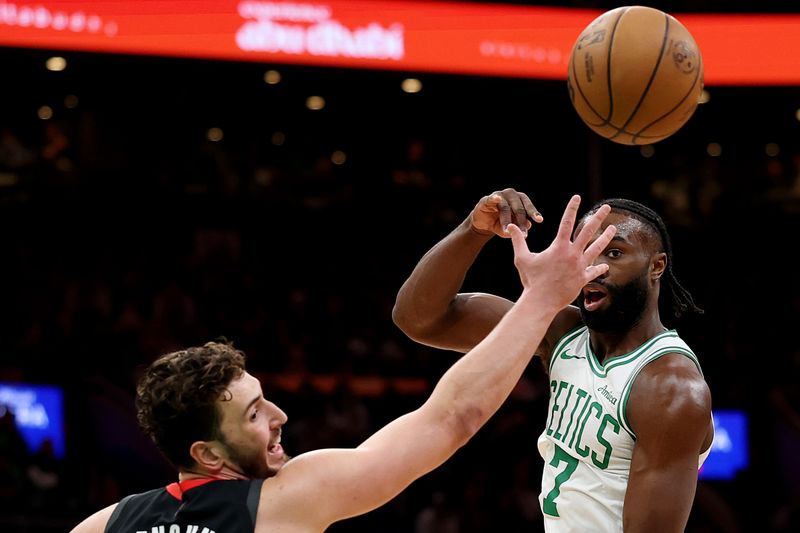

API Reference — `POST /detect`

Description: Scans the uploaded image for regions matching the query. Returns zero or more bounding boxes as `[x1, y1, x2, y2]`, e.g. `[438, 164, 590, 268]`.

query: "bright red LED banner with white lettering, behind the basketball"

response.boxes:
[0, 0, 800, 85]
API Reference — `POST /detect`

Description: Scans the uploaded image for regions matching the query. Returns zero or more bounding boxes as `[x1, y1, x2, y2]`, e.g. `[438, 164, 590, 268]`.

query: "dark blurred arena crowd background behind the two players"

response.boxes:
[0, 1, 800, 533]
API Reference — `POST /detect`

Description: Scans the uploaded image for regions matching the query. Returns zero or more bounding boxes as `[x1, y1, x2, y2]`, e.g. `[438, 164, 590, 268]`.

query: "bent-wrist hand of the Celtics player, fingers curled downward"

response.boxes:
[470, 189, 543, 238]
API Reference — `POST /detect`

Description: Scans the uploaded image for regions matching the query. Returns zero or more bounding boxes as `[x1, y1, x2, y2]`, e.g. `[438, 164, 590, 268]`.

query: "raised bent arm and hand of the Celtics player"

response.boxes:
[392, 189, 542, 352]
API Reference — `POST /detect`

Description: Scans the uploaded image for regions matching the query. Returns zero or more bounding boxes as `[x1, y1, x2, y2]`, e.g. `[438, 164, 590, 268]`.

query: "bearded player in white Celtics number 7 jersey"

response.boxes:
[393, 189, 714, 533]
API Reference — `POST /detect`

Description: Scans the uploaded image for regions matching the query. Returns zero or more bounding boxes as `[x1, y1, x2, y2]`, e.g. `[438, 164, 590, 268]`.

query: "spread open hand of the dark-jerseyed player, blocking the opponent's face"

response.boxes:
[508, 195, 617, 309]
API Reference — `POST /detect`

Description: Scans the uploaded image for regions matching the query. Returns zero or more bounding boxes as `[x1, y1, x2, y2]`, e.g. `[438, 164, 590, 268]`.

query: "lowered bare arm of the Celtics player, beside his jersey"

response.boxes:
[623, 354, 713, 533]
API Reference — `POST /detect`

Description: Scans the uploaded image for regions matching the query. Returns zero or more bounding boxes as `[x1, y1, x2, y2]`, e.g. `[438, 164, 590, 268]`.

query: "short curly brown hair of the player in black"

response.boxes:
[136, 342, 245, 468]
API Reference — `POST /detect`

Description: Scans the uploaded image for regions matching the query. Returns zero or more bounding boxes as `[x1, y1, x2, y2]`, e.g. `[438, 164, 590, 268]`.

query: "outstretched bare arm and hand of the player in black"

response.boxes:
[266, 196, 615, 529]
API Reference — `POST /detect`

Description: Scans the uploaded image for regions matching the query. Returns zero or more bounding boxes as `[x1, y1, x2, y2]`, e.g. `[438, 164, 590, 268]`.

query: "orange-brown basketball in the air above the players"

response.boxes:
[567, 6, 703, 145]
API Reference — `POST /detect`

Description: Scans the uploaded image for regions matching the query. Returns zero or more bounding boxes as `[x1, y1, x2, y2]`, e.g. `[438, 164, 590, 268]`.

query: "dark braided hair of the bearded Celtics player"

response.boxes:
[585, 198, 703, 318]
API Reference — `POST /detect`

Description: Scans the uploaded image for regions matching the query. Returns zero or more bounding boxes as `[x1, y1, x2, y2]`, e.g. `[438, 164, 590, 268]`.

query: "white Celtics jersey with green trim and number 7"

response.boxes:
[538, 327, 705, 533]
